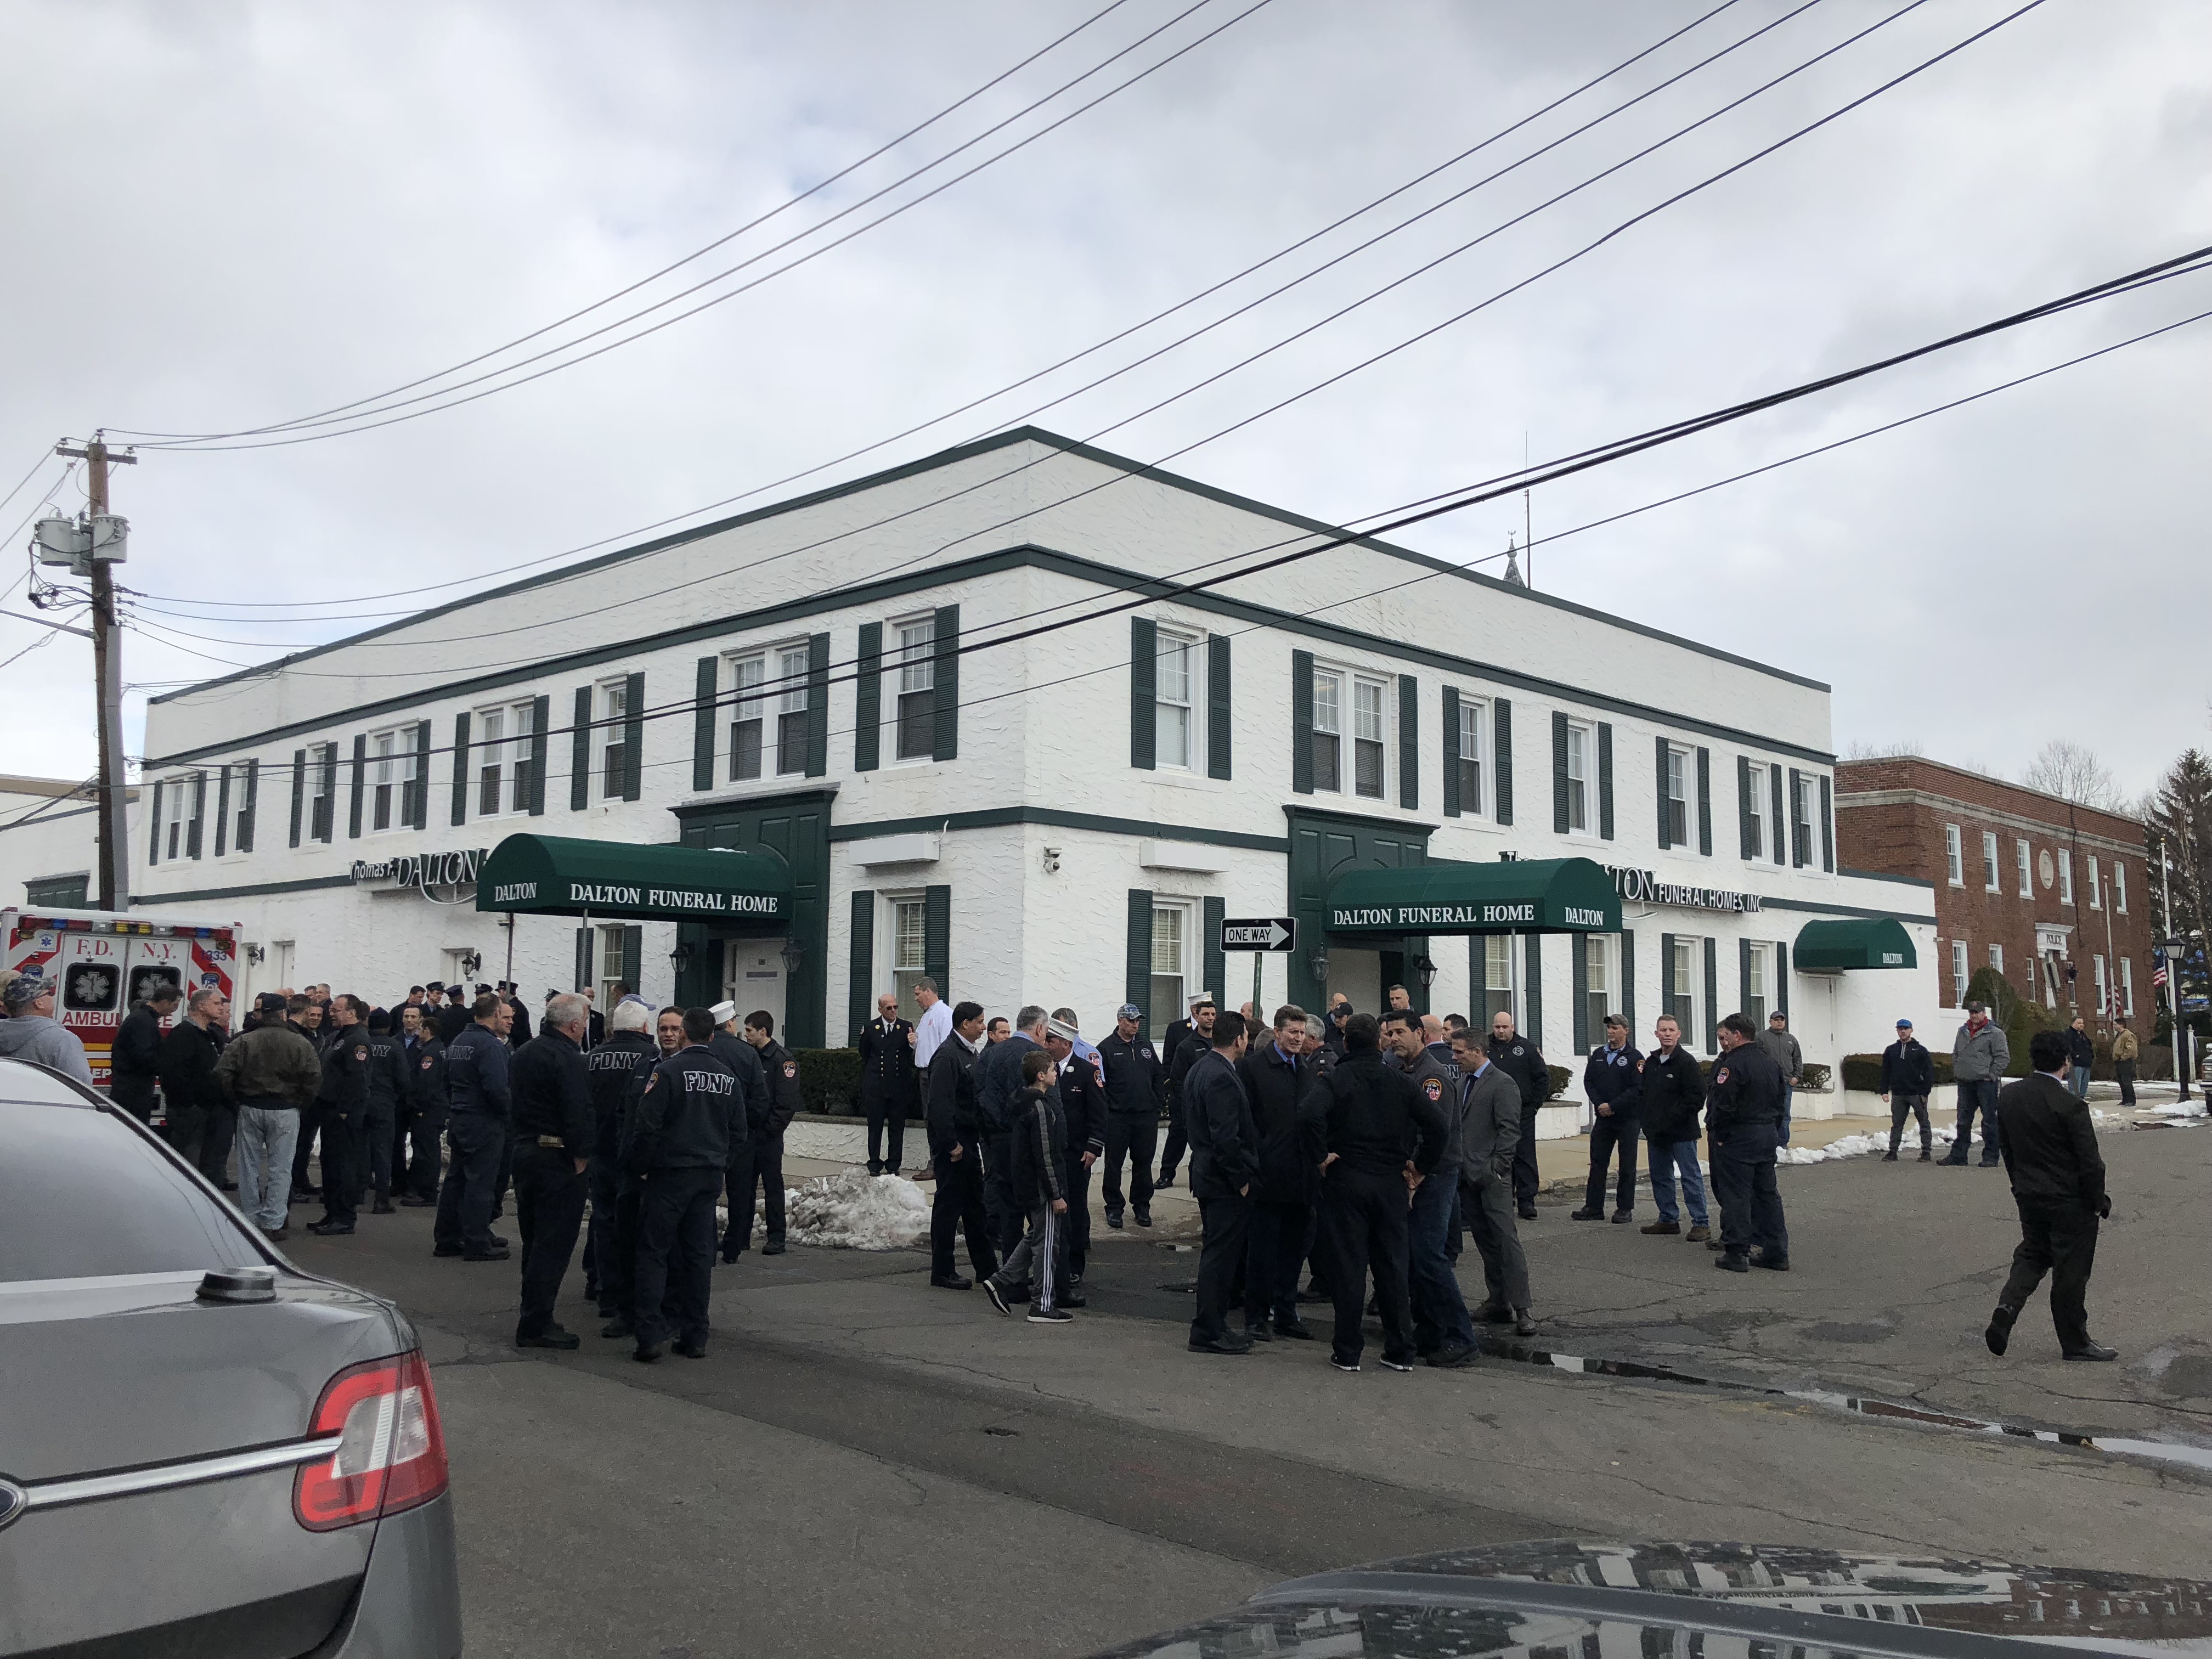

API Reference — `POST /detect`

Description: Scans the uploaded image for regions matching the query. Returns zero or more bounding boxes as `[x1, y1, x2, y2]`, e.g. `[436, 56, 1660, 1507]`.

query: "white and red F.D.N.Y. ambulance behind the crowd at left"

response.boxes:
[0, 905, 244, 1088]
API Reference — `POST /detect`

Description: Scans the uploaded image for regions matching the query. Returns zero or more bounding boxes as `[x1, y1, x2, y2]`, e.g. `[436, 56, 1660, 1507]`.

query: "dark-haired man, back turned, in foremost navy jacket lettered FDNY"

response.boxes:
[608, 1009, 746, 1363]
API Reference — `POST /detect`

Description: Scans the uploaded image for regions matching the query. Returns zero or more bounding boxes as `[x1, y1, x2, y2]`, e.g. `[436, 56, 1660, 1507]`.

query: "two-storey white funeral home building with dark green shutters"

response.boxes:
[0, 429, 1938, 1110]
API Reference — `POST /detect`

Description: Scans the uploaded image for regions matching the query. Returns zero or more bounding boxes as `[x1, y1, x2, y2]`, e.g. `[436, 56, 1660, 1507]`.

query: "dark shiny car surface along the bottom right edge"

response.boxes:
[1099, 1542, 2212, 1659]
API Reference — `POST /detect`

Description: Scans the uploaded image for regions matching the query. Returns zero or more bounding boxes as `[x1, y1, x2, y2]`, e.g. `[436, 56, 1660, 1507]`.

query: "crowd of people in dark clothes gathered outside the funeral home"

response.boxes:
[0, 960, 2111, 1372]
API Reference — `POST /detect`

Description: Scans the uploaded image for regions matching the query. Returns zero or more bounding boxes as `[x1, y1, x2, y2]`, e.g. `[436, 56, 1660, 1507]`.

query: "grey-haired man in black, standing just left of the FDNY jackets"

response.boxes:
[509, 991, 600, 1347]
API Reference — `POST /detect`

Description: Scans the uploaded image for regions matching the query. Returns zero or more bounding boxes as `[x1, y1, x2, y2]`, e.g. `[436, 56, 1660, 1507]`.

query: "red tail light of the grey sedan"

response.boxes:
[292, 1354, 447, 1533]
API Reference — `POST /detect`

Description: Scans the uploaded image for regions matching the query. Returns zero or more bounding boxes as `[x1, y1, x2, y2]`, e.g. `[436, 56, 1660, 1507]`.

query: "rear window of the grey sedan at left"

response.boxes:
[0, 1092, 266, 1283]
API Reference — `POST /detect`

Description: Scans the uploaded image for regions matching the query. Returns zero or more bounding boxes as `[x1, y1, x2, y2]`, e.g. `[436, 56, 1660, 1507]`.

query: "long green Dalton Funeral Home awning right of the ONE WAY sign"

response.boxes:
[1327, 858, 1621, 934]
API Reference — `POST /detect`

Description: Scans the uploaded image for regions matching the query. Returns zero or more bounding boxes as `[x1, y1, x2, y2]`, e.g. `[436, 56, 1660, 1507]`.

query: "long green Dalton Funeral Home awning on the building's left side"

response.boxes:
[476, 836, 792, 922]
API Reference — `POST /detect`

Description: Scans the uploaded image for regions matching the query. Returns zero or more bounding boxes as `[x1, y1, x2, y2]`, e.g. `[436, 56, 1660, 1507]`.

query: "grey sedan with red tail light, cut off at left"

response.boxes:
[0, 1059, 460, 1659]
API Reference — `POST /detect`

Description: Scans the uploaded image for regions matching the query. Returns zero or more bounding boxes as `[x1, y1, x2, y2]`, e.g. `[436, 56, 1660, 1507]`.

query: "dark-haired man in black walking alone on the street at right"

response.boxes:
[1982, 1031, 2119, 1361]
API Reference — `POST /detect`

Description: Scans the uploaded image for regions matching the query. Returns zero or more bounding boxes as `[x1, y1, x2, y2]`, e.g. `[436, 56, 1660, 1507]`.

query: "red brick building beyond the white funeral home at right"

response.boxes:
[1836, 754, 2157, 1035]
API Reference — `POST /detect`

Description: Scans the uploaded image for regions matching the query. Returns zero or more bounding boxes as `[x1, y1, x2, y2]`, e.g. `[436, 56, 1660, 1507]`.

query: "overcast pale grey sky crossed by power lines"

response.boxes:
[0, 0, 2212, 794]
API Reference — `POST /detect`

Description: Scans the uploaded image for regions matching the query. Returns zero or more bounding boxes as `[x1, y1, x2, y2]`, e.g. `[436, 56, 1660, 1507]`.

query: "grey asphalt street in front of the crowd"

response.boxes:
[292, 1110, 2212, 1659]
